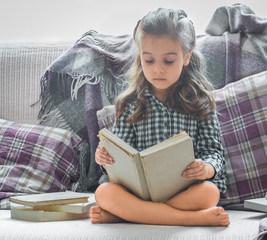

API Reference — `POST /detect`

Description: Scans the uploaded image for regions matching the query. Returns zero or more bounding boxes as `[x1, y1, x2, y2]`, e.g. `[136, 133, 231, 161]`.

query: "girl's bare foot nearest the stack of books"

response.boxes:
[90, 206, 123, 223]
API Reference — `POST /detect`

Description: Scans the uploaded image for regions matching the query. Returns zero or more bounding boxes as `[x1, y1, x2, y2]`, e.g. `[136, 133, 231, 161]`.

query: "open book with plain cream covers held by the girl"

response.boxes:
[99, 128, 195, 202]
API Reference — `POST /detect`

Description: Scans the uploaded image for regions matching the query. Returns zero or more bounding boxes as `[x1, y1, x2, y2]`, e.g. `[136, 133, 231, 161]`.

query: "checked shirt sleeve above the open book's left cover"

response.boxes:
[112, 101, 136, 148]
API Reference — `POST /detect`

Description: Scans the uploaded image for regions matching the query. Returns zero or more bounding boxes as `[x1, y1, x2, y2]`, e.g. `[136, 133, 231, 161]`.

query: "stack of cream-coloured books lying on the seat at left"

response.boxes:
[9, 191, 96, 222]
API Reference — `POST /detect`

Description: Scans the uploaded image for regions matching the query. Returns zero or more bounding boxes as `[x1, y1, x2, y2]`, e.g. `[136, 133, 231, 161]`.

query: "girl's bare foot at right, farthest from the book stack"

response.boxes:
[195, 207, 230, 227]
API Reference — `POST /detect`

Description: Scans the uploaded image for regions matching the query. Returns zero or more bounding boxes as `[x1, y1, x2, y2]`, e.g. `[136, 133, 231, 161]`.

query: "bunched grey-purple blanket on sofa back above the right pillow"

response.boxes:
[197, 4, 267, 88]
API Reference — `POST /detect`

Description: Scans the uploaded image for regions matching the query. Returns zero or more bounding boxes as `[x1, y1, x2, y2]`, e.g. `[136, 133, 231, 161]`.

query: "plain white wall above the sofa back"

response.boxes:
[0, 0, 267, 42]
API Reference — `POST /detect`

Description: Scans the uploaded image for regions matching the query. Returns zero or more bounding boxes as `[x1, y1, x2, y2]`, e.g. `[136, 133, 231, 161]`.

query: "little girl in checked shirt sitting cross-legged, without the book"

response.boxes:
[90, 8, 229, 226]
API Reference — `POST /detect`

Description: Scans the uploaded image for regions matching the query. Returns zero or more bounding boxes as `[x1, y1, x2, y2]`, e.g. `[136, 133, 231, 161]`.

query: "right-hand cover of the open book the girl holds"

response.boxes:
[140, 138, 195, 202]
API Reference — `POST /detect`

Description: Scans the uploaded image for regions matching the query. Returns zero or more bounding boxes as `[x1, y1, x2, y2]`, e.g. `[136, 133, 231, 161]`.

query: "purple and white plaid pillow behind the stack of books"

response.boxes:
[0, 119, 82, 207]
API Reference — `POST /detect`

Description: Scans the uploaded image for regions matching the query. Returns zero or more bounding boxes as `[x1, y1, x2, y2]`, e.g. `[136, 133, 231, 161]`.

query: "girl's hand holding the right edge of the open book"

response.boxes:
[183, 159, 215, 180]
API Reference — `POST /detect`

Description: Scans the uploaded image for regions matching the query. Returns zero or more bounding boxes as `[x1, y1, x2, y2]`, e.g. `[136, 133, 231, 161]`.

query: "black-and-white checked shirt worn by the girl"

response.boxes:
[113, 89, 226, 192]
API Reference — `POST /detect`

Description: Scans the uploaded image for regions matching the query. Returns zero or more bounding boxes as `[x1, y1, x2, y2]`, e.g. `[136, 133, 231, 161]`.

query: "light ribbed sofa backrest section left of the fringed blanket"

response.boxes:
[0, 41, 72, 123]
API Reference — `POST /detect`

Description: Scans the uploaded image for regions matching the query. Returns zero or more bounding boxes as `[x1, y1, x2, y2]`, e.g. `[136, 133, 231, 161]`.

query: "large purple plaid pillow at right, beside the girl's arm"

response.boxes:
[216, 72, 267, 206]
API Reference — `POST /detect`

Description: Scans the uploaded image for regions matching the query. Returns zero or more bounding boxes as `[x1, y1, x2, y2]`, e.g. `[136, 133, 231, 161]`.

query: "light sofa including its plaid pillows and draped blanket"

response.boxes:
[0, 5, 267, 240]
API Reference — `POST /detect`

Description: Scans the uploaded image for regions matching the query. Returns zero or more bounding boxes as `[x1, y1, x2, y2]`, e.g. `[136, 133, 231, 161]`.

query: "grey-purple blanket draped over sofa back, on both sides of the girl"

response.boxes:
[39, 4, 267, 191]
